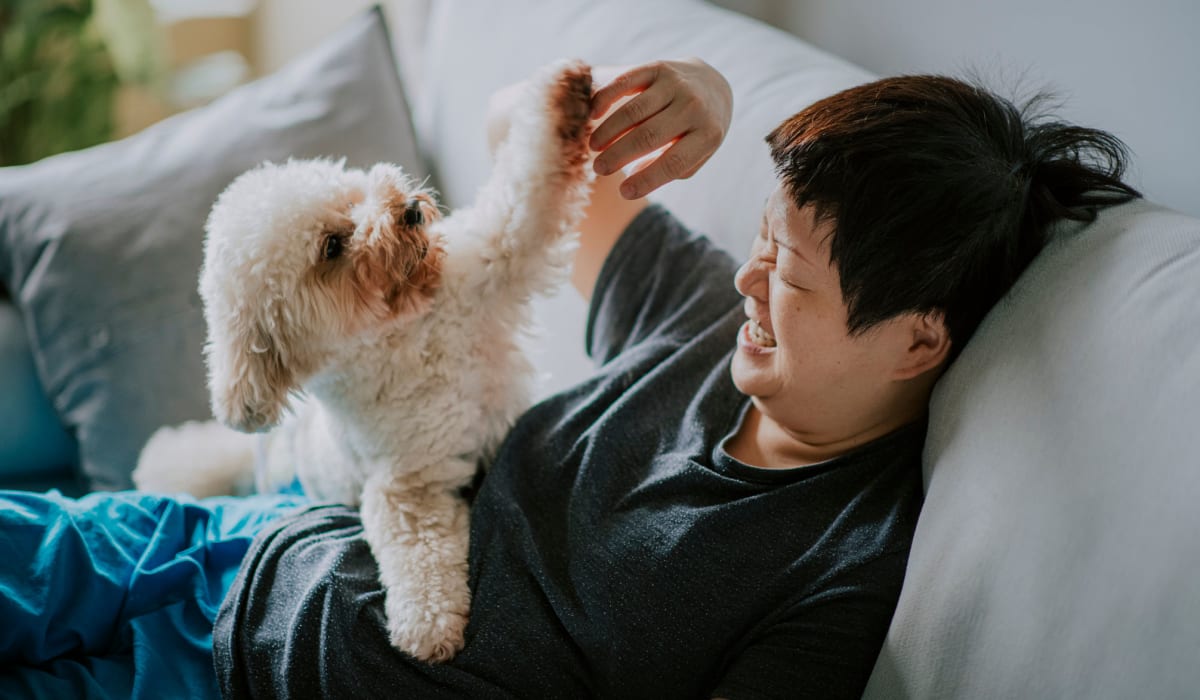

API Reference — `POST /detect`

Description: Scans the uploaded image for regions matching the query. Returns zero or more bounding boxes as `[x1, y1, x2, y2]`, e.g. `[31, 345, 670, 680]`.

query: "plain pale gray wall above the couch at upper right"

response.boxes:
[719, 0, 1200, 216]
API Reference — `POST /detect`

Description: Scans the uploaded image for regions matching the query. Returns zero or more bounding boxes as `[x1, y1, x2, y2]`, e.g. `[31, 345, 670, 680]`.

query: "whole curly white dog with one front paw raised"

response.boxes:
[134, 62, 592, 660]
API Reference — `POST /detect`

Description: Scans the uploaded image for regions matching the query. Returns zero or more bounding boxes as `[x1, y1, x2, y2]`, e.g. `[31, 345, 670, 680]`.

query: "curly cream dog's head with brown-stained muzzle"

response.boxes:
[200, 161, 444, 431]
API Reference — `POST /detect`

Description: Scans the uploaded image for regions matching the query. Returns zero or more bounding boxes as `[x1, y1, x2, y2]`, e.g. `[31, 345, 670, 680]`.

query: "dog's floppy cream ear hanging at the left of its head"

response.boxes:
[205, 321, 293, 432]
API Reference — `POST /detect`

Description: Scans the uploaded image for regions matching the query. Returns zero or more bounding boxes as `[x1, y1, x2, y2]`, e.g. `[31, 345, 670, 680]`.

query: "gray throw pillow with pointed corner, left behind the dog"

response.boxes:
[0, 8, 426, 490]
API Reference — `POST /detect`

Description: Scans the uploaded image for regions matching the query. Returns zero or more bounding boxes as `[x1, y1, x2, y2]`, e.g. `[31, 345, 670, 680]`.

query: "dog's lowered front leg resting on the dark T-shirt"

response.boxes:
[361, 474, 470, 662]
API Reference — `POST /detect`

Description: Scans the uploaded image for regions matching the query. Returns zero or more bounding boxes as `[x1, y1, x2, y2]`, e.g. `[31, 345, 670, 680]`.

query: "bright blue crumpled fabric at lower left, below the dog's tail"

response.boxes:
[0, 491, 302, 700]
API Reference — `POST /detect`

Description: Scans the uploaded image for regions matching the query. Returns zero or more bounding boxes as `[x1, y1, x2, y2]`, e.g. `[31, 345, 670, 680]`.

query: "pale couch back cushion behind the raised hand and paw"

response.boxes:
[413, 0, 872, 395]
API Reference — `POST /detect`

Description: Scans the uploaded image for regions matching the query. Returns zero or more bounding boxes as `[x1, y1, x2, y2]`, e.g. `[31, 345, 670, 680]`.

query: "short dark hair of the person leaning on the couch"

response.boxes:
[767, 76, 1140, 358]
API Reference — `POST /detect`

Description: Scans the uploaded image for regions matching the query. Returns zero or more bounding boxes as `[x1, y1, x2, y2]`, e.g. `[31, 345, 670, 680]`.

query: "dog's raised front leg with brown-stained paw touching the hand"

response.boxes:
[445, 62, 593, 300]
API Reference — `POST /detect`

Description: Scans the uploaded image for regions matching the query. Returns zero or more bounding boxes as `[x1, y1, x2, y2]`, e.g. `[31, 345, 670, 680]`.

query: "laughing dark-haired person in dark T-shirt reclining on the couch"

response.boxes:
[0, 61, 1136, 698]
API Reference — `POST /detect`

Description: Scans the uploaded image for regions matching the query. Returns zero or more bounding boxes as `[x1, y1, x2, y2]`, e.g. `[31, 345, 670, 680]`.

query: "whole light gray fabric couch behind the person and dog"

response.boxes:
[0, 0, 1200, 699]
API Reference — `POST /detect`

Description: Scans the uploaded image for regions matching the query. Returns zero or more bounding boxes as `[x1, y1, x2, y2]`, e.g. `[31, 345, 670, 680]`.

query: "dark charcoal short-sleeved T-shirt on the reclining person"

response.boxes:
[214, 208, 924, 699]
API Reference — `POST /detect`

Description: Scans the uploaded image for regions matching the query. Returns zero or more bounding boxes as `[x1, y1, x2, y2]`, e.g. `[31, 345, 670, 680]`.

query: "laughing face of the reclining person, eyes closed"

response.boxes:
[731, 187, 944, 466]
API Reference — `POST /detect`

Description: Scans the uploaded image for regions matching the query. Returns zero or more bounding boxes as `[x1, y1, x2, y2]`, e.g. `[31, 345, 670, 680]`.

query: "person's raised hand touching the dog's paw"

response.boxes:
[590, 59, 733, 199]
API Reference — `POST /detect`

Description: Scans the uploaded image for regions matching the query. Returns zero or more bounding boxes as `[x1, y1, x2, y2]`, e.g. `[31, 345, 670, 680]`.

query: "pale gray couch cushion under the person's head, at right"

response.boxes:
[866, 201, 1200, 700]
